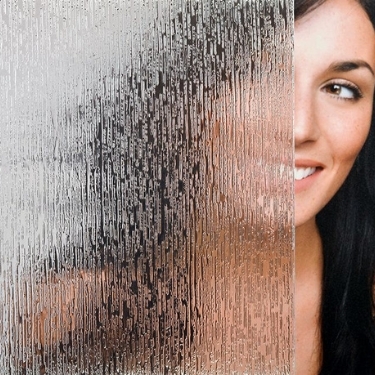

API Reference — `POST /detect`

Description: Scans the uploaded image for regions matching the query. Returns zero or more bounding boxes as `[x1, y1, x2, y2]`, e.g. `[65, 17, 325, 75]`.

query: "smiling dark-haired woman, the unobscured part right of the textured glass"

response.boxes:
[295, 0, 375, 375]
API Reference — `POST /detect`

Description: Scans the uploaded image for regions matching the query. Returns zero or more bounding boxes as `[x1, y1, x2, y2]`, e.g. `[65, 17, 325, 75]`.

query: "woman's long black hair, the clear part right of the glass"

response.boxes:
[295, 0, 375, 375]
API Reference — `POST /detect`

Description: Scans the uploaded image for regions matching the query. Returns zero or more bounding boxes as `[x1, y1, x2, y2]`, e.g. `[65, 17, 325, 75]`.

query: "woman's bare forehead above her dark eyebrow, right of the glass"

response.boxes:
[295, 0, 375, 70]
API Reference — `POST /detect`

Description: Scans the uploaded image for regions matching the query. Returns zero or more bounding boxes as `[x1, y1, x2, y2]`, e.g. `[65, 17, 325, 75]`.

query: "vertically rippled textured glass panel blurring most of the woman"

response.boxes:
[0, 0, 293, 375]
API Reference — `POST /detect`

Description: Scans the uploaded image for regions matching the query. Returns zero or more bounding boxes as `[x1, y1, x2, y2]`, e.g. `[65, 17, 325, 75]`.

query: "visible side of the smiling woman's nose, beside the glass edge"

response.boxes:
[294, 89, 320, 147]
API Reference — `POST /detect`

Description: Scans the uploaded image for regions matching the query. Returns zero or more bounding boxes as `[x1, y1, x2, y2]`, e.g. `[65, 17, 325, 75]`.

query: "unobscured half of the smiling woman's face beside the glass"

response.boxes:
[294, 0, 375, 227]
